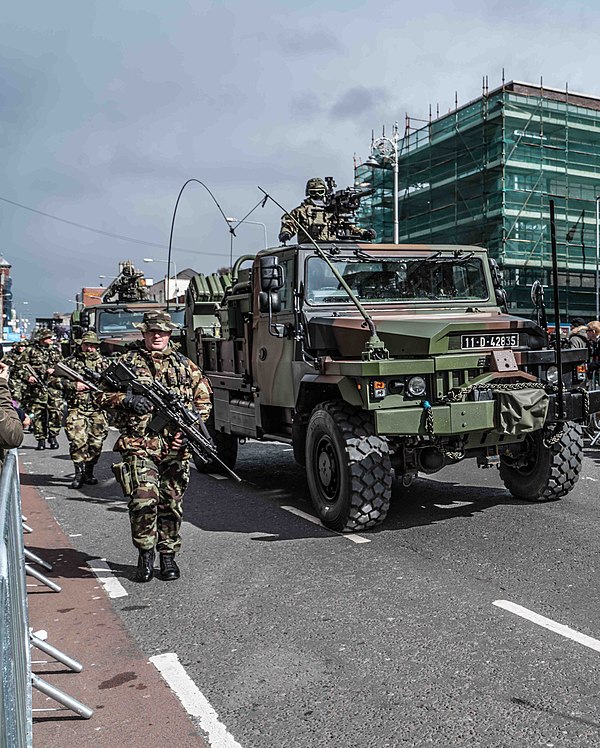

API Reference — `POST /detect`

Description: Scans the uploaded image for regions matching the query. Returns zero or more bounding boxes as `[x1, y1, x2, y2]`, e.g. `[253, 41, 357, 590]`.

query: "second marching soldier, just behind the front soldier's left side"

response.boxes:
[64, 332, 108, 488]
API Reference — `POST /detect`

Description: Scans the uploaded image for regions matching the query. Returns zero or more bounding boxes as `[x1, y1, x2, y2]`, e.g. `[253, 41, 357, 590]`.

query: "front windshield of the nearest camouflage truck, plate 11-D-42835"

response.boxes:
[305, 252, 489, 304]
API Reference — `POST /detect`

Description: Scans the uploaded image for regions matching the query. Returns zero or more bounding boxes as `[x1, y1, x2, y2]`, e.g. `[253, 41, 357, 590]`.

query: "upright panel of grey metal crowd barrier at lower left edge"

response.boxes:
[0, 449, 33, 748]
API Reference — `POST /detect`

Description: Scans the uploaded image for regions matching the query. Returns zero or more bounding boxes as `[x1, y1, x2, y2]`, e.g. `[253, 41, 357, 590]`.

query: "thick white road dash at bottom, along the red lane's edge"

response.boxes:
[150, 652, 242, 748]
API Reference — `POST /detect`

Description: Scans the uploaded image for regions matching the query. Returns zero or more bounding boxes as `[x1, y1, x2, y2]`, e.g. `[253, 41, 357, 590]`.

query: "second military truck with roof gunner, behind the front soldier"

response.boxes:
[71, 260, 185, 356]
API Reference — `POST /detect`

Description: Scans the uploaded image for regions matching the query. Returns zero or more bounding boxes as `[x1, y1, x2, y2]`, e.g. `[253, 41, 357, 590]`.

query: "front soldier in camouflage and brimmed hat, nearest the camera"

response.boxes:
[98, 311, 210, 582]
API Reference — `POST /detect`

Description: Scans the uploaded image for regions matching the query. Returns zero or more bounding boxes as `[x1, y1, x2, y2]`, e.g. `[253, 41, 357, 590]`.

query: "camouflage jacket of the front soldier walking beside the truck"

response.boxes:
[96, 343, 211, 459]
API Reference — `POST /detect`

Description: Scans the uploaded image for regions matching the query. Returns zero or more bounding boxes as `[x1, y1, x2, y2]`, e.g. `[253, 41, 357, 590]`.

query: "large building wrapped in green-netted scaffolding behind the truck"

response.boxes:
[355, 81, 600, 319]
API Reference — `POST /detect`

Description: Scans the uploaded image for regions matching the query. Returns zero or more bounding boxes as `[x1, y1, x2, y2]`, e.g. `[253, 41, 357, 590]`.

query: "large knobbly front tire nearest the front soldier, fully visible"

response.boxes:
[306, 401, 392, 532]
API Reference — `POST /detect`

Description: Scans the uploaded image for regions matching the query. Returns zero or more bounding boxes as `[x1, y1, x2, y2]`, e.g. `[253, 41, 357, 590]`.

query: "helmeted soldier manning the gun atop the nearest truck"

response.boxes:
[279, 177, 337, 244]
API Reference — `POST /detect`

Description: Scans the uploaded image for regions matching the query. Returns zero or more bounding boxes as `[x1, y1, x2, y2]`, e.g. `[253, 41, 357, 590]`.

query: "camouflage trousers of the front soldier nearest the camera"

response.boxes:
[123, 454, 190, 553]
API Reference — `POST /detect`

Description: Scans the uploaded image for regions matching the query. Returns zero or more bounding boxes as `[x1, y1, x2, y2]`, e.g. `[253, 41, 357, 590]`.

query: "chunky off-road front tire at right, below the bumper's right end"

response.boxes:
[500, 421, 583, 501]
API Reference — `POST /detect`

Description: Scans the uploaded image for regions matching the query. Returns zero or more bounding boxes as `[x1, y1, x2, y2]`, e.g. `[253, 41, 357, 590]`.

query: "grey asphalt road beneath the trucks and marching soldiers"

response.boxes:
[20, 434, 600, 748]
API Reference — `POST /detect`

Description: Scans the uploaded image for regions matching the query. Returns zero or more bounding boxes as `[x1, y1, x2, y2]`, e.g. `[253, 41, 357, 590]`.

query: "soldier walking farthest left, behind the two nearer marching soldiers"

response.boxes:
[23, 329, 63, 450]
